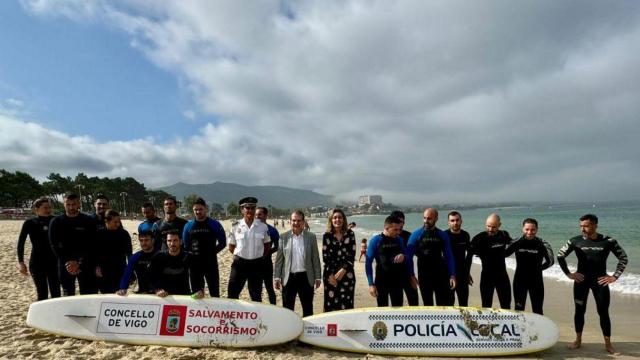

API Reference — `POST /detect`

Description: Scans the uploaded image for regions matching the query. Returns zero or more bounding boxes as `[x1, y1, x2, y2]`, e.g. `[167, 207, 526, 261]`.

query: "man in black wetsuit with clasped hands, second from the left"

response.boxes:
[49, 194, 98, 296]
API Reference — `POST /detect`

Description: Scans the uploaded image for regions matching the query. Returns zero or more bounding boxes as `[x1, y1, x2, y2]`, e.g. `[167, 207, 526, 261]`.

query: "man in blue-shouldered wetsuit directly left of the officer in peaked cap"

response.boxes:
[182, 198, 227, 297]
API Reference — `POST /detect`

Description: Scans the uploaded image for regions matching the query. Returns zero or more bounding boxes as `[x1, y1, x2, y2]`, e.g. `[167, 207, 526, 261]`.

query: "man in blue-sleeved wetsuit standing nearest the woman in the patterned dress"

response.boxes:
[364, 216, 409, 306]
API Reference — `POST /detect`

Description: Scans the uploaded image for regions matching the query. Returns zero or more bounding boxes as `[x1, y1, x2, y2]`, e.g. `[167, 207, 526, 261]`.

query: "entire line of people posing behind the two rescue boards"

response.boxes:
[18, 194, 627, 352]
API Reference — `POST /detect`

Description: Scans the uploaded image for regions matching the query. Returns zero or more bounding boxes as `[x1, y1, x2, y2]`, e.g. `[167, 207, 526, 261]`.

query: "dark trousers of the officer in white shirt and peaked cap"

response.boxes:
[228, 256, 263, 302]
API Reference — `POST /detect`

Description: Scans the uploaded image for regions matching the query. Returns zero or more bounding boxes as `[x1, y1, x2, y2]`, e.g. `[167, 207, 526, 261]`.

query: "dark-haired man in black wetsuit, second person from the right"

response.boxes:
[506, 218, 553, 315]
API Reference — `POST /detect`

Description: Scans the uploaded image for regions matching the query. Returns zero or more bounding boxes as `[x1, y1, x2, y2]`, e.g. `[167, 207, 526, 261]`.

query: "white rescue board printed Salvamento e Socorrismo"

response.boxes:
[27, 295, 302, 347]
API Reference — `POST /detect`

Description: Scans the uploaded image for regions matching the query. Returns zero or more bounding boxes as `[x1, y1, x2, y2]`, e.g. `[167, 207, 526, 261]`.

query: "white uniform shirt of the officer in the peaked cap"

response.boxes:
[229, 219, 271, 260]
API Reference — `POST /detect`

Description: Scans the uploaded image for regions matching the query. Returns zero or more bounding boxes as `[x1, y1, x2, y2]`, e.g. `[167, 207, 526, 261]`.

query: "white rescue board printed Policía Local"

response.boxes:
[299, 306, 559, 357]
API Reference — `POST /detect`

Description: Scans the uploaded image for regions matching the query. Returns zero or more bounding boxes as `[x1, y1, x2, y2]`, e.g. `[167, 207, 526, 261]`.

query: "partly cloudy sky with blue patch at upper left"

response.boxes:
[0, 0, 640, 204]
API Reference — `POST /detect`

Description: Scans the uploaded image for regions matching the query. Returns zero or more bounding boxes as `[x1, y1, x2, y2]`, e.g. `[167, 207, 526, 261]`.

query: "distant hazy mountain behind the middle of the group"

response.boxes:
[157, 181, 334, 209]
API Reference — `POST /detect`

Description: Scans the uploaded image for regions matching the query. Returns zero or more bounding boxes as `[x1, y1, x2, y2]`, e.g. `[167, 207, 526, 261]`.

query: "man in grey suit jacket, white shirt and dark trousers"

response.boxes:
[273, 210, 322, 316]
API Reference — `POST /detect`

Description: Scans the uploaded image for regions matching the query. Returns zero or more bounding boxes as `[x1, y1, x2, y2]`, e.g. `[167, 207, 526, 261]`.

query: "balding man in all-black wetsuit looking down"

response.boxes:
[466, 214, 512, 309]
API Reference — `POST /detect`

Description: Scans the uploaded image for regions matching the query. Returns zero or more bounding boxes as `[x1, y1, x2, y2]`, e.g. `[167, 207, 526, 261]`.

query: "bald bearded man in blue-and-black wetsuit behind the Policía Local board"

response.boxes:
[407, 208, 456, 306]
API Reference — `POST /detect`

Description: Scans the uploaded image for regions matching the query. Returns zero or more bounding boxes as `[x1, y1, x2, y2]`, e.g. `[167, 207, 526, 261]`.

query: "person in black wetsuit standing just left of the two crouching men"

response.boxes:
[96, 210, 132, 294]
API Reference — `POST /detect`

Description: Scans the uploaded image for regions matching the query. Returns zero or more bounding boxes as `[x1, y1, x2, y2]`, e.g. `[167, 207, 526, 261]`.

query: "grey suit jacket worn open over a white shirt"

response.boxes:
[273, 230, 322, 286]
